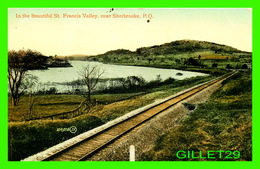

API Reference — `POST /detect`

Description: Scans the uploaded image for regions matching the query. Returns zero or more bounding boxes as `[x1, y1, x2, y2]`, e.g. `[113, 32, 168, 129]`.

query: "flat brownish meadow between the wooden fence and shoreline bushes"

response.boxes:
[8, 93, 142, 121]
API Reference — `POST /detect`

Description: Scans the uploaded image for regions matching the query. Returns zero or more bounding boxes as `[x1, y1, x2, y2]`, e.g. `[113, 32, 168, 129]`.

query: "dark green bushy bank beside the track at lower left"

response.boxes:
[8, 115, 103, 161]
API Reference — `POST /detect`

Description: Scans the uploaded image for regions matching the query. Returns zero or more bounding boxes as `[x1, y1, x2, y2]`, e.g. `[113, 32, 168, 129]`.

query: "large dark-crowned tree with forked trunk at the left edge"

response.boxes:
[8, 49, 48, 106]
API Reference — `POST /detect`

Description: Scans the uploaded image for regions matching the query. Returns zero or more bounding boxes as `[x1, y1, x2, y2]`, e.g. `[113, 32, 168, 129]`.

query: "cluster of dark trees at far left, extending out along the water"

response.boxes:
[8, 49, 74, 106]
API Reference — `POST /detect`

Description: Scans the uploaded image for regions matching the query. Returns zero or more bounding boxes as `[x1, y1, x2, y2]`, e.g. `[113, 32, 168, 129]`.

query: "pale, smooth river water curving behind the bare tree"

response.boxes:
[28, 61, 207, 91]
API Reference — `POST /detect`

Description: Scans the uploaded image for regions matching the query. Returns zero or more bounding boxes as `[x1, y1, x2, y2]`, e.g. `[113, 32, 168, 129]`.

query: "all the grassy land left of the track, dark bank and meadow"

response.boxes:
[8, 76, 213, 160]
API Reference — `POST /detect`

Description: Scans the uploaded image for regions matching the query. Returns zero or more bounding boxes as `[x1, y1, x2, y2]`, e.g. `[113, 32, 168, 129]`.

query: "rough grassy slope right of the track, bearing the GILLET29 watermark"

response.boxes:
[142, 72, 252, 161]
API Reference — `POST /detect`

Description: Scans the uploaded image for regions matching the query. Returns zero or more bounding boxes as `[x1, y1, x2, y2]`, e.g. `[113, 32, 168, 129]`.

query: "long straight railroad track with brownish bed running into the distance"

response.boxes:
[35, 72, 235, 161]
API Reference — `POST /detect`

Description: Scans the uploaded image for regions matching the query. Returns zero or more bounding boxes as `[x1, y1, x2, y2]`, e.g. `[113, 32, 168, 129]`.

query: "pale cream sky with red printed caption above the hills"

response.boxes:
[8, 8, 252, 56]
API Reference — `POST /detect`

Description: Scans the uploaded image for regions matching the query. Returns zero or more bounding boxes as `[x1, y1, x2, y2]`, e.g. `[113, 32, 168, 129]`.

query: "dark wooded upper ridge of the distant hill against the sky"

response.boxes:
[85, 40, 250, 60]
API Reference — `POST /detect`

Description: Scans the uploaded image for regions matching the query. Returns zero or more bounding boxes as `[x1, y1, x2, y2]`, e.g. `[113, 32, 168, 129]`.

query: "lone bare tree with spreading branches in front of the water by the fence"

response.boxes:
[79, 65, 104, 102]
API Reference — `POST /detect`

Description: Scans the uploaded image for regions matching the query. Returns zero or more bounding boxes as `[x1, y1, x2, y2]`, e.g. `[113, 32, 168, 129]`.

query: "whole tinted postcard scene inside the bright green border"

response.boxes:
[8, 8, 252, 161]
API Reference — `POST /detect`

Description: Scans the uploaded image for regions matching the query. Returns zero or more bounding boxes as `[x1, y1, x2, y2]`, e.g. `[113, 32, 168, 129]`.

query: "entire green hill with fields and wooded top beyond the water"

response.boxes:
[81, 40, 252, 72]
